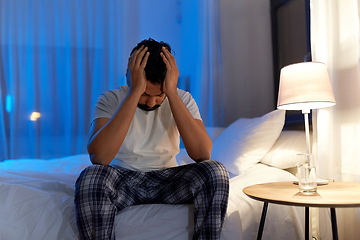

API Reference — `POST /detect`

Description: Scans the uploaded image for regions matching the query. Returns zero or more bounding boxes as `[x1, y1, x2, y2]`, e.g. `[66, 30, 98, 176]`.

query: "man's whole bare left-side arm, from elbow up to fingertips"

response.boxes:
[87, 47, 149, 165]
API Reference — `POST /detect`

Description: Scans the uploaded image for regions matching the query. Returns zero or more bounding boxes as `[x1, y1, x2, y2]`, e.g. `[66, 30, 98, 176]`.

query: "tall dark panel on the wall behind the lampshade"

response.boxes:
[270, 0, 311, 128]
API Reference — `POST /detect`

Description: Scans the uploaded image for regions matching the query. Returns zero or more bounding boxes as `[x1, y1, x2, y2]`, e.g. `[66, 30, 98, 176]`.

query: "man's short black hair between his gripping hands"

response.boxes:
[130, 38, 171, 84]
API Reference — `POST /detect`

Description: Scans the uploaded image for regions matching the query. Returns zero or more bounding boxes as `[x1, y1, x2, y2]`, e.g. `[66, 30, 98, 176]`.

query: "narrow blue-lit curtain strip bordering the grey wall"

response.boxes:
[197, 0, 224, 126]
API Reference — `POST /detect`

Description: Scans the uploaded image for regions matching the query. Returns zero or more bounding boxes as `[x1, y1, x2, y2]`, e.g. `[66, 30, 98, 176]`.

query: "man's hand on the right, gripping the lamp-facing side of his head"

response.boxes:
[160, 47, 179, 96]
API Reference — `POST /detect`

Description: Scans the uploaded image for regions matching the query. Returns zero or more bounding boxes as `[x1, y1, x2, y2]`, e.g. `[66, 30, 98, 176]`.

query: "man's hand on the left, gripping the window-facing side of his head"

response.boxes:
[126, 46, 150, 94]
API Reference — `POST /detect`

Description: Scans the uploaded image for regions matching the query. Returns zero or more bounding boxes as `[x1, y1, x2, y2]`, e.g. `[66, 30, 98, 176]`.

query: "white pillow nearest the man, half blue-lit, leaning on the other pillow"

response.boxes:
[211, 110, 285, 175]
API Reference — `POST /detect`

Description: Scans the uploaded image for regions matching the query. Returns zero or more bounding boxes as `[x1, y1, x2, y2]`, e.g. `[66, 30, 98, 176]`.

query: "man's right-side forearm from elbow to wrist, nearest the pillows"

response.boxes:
[167, 92, 212, 162]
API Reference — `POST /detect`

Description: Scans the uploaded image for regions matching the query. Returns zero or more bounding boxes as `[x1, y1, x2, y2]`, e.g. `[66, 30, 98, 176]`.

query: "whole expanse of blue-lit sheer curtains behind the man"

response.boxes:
[0, 0, 222, 161]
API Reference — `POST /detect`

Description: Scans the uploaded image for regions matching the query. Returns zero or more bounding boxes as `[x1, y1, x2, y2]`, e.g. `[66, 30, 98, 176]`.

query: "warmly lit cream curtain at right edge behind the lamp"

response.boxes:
[311, 0, 360, 239]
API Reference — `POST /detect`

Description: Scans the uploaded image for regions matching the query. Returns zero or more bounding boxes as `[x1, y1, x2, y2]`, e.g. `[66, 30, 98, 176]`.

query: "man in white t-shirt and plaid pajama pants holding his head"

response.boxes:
[75, 39, 229, 240]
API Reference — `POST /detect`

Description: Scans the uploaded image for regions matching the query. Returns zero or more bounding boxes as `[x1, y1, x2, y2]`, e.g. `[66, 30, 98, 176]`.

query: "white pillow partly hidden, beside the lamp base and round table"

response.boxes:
[261, 131, 306, 169]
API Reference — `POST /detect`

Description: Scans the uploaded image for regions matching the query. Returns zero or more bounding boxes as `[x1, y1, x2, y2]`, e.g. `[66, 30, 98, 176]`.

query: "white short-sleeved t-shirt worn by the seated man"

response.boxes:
[93, 85, 201, 172]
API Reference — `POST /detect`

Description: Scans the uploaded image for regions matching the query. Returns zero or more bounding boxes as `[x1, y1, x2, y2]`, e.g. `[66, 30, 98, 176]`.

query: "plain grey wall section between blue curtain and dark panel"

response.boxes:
[220, 0, 275, 125]
